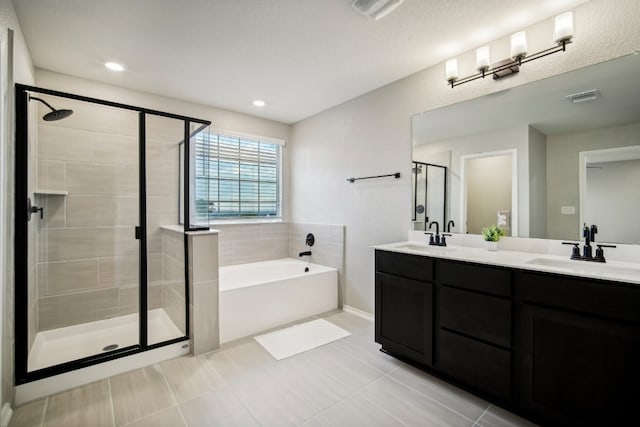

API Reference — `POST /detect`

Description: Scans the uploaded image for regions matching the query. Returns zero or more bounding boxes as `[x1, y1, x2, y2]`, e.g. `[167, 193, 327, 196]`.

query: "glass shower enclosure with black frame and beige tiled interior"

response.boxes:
[15, 85, 210, 384]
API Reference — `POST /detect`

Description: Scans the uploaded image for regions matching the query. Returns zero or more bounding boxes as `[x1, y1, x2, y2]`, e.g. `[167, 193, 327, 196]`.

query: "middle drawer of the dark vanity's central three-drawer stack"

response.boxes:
[440, 286, 511, 348]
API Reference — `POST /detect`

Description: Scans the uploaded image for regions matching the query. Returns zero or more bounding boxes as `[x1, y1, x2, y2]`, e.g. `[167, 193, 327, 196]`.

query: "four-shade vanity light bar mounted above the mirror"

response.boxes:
[445, 12, 573, 88]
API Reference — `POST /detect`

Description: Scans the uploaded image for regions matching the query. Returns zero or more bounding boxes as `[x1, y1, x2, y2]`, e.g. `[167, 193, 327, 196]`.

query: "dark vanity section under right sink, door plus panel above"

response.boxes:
[517, 272, 640, 425]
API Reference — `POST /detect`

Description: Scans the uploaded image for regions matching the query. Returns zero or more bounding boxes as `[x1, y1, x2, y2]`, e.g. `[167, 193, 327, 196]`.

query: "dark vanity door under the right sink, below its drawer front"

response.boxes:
[520, 304, 640, 425]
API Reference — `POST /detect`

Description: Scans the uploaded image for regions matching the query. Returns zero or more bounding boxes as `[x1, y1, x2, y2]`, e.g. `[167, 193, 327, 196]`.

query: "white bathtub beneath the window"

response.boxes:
[219, 258, 338, 343]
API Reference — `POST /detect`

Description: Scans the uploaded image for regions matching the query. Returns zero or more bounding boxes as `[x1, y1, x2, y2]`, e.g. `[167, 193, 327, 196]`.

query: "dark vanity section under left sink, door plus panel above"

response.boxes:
[375, 252, 433, 365]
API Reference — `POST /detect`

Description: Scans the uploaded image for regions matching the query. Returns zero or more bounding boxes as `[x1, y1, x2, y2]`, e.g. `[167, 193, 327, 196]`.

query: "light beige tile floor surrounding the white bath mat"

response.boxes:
[10, 311, 533, 427]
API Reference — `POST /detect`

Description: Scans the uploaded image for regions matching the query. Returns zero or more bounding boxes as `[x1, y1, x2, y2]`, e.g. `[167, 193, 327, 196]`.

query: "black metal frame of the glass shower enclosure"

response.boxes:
[13, 83, 211, 385]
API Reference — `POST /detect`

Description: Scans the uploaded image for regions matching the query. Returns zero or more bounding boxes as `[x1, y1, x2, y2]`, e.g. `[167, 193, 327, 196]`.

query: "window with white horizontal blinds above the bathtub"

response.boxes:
[195, 132, 281, 220]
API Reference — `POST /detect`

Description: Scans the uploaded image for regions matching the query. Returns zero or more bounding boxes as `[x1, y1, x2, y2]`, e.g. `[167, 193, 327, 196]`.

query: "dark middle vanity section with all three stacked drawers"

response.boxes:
[435, 260, 512, 400]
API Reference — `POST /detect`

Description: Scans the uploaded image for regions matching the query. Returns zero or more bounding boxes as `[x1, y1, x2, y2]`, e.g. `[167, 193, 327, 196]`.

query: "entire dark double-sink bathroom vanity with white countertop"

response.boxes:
[375, 246, 640, 425]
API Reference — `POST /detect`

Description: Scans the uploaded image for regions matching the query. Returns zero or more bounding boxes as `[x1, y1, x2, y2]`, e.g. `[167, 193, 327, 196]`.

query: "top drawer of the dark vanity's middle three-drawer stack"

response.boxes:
[438, 261, 511, 297]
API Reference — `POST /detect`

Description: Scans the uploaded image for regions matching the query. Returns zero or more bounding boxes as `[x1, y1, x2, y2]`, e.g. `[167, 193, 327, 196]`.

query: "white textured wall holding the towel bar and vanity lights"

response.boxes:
[291, 0, 640, 312]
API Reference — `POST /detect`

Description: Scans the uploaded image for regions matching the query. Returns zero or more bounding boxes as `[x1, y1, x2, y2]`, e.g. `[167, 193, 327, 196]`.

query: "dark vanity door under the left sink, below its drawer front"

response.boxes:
[375, 273, 433, 365]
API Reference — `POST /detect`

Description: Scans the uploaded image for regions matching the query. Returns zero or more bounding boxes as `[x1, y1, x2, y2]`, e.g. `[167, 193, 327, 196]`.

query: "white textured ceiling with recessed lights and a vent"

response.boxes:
[14, 0, 586, 123]
